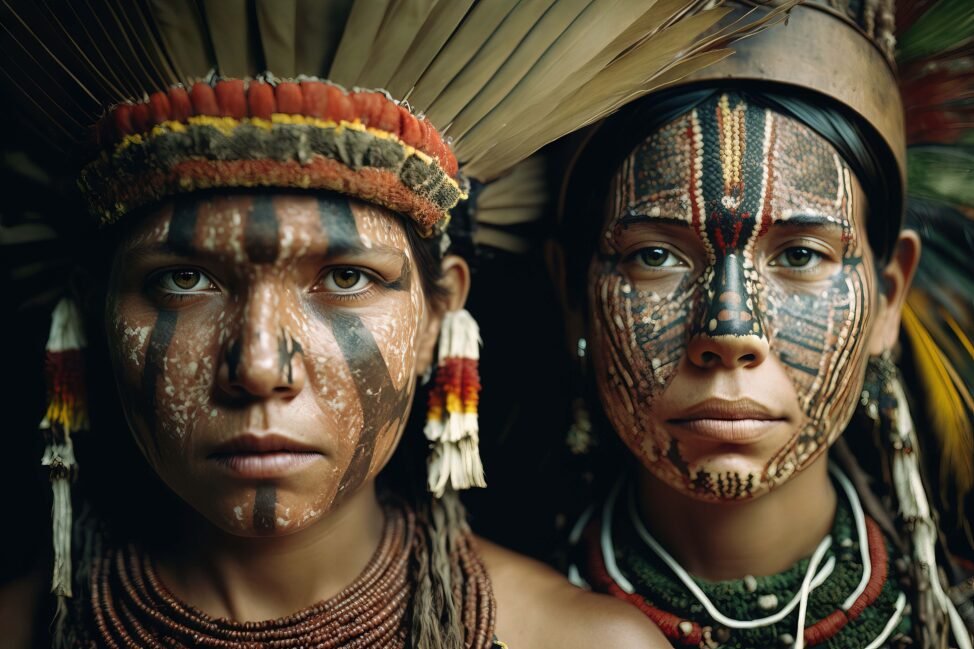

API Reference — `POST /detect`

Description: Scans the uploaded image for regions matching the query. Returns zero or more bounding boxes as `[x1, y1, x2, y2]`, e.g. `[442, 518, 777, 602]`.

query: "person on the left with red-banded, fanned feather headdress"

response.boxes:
[0, 0, 784, 649]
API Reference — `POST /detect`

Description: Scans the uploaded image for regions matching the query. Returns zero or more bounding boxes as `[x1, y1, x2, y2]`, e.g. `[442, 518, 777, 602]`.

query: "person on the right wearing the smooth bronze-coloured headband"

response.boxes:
[554, 1, 974, 649]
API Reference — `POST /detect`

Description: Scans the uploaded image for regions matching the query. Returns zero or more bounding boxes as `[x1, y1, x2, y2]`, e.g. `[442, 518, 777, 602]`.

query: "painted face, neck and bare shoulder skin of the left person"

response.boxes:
[89, 194, 666, 647]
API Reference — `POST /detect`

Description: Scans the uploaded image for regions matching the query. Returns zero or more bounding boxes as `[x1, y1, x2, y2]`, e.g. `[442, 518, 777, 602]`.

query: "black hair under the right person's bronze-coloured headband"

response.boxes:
[556, 82, 903, 302]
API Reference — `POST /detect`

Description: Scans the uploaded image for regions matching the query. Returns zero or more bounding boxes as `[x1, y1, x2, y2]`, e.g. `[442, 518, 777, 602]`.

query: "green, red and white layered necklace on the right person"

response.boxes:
[570, 467, 909, 649]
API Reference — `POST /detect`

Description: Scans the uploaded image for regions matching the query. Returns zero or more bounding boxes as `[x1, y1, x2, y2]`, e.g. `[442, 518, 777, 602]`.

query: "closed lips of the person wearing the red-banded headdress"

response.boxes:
[207, 432, 324, 479]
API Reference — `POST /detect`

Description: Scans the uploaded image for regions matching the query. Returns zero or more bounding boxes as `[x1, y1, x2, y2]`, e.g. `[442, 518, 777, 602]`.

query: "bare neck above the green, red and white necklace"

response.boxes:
[638, 454, 836, 581]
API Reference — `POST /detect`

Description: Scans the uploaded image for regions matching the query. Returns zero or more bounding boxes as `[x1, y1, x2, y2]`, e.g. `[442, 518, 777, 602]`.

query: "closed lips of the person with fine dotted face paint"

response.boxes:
[666, 399, 788, 444]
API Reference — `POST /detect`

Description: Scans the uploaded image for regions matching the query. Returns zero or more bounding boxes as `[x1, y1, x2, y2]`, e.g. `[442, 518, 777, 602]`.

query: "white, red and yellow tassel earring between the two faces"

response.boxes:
[424, 309, 487, 498]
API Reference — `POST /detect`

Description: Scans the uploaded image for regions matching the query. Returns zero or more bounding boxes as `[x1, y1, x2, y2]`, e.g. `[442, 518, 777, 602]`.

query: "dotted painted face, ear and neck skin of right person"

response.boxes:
[556, 96, 919, 580]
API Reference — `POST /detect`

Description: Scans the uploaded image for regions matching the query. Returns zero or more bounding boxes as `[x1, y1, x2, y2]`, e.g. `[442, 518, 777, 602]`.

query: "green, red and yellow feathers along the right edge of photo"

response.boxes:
[897, 0, 974, 549]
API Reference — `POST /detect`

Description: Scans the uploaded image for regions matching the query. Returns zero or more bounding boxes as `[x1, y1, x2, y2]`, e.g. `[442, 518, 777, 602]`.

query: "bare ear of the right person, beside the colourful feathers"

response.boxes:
[869, 230, 920, 356]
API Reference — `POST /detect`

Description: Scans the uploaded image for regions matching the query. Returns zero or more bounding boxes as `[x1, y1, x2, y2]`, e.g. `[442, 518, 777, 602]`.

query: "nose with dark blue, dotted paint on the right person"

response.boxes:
[687, 255, 769, 369]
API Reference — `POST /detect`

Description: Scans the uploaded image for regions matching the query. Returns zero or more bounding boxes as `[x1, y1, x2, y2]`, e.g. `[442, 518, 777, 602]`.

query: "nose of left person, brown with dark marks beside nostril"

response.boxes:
[217, 296, 307, 399]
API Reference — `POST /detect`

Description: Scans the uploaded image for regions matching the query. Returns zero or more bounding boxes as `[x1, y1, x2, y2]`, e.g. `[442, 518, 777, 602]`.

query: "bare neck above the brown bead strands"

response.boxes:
[158, 481, 383, 621]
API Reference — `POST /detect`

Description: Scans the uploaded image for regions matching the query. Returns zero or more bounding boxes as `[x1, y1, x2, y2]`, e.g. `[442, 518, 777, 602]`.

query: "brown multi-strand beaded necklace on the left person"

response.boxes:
[91, 504, 494, 649]
